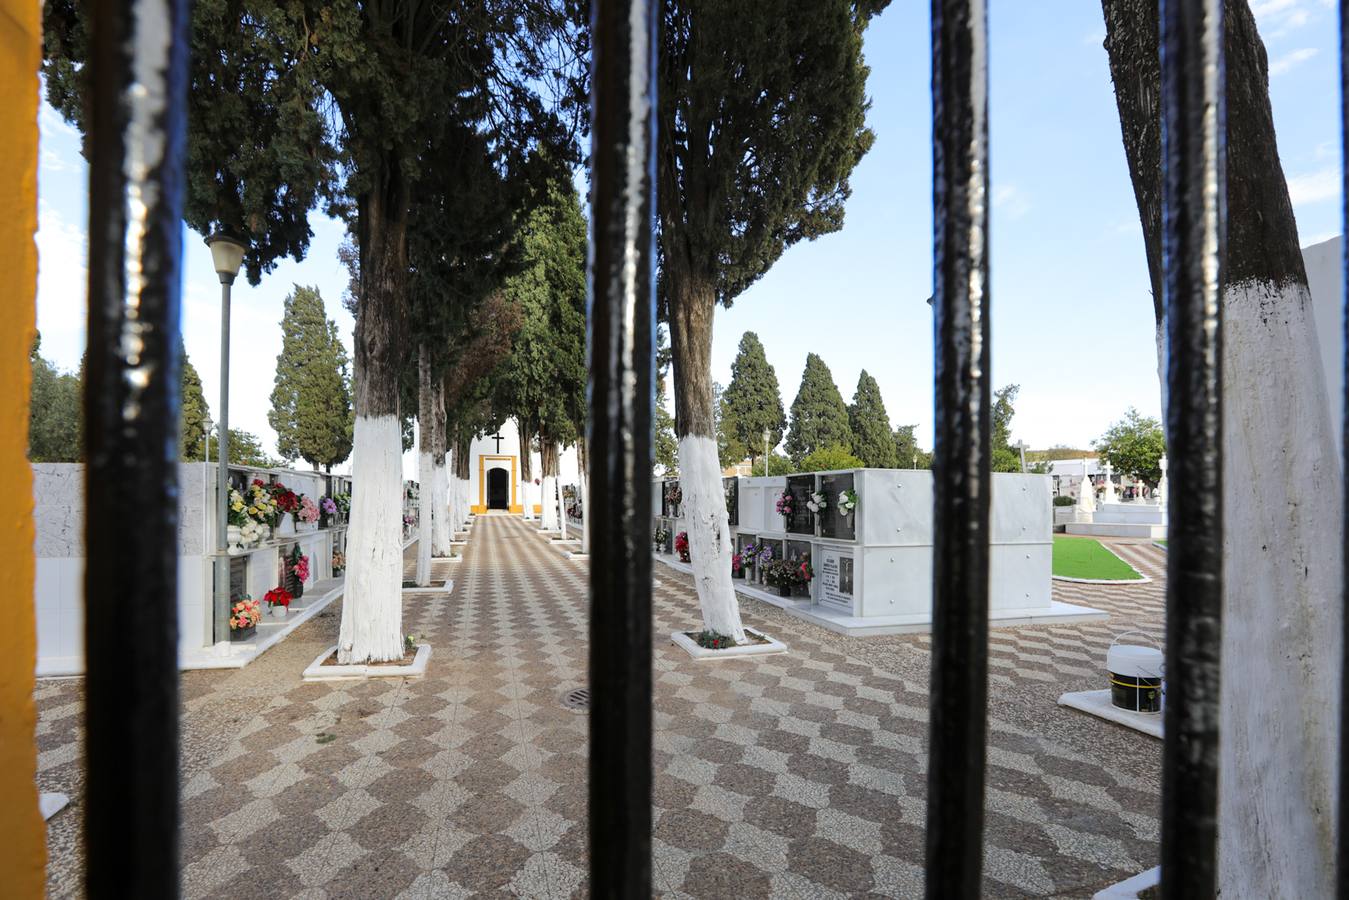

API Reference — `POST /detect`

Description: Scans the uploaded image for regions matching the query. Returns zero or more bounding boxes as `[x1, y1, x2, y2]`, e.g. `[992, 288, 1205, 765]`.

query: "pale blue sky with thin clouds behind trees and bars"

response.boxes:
[38, 0, 1341, 464]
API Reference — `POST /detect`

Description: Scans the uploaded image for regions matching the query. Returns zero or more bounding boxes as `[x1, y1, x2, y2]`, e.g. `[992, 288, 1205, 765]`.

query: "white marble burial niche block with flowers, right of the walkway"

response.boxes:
[653, 468, 1106, 636]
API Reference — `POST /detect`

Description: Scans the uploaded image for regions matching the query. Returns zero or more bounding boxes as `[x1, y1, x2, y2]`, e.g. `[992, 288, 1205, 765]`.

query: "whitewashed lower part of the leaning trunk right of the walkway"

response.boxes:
[679, 434, 745, 644]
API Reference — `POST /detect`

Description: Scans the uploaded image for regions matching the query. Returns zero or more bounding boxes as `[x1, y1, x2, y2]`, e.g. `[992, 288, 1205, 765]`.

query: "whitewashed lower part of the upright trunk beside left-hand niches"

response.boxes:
[337, 416, 403, 664]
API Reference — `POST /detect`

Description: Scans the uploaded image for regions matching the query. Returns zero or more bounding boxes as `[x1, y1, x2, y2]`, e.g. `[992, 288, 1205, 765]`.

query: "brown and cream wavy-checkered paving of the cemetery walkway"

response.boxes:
[36, 515, 1164, 900]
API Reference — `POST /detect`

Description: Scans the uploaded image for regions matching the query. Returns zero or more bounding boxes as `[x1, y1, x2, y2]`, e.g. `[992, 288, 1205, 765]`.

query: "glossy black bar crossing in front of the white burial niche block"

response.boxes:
[927, 0, 992, 900]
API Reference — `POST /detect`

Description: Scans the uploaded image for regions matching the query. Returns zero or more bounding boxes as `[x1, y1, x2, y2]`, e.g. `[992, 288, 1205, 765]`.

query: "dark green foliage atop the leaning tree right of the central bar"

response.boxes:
[656, 0, 886, 305]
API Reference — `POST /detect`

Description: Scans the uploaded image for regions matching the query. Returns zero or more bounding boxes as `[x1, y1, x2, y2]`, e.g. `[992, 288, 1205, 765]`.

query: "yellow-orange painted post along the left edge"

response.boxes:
[0, 0, 47, 897]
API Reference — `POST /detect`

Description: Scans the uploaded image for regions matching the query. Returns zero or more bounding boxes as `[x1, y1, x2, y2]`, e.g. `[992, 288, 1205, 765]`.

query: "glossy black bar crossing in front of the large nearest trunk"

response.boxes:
[1161, 0, 1226, 897]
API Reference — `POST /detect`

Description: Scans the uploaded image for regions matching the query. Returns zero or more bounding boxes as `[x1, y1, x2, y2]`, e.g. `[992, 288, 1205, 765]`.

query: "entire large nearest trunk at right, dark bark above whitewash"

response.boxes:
[1102, 0, 1342, 899]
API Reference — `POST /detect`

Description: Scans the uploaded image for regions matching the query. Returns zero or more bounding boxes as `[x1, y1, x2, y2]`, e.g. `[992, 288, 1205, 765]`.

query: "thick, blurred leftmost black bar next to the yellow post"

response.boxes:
[84, 0, 188, 897]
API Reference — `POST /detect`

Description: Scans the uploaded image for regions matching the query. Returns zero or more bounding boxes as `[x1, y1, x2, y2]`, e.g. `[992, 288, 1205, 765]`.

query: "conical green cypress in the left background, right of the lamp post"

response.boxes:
[267, 285, 352, 468]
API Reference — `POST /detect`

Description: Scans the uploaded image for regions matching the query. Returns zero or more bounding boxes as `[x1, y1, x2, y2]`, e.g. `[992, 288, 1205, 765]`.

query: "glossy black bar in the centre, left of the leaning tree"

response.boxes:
[587, 0, 657, 897]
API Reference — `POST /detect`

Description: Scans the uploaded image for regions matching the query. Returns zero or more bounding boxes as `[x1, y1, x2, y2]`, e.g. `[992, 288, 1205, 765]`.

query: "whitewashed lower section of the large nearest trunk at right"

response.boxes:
[1218, 282, 1342, 897]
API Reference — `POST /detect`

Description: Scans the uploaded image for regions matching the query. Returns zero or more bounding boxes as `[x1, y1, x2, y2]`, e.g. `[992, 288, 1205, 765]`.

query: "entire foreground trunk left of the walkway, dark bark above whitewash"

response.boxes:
[337, 166, 407, 664]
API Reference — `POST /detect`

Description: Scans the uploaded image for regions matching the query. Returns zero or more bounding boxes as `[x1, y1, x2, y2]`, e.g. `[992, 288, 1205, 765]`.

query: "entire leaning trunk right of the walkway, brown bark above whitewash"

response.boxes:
[669, 273, 745, 644]
